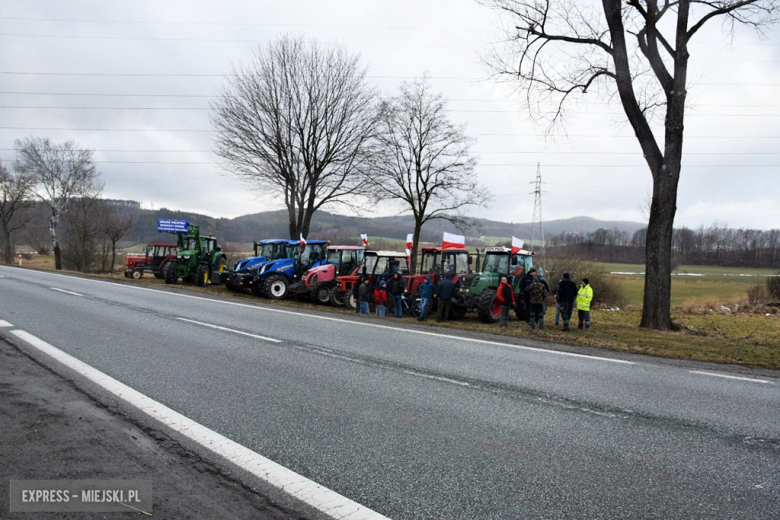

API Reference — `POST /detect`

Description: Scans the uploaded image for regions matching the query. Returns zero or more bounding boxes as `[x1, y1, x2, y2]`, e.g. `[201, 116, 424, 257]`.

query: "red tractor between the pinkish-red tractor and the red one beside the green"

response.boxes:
[331, 251, 409, 314]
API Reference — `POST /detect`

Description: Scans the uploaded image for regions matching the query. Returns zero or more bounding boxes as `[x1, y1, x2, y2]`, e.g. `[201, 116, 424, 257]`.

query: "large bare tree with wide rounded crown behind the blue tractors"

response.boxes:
[212, 37, 378, 239]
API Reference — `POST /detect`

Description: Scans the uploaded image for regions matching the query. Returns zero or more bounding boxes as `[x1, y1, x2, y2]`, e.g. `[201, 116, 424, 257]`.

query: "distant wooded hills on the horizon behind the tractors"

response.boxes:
[124, 208, 644, 245]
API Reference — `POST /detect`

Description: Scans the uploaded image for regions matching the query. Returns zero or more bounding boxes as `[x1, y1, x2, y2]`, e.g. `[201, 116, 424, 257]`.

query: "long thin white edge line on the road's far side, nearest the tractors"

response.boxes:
[0, 271, 636, 365]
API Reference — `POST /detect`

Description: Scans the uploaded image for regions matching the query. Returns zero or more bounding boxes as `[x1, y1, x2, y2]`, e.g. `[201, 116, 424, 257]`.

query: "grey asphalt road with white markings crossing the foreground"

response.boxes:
[0, 267, 780, 519]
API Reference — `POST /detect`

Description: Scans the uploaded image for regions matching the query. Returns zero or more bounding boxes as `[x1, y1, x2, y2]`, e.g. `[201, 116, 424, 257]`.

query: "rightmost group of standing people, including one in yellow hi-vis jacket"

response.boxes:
[496, 267, 593, 330]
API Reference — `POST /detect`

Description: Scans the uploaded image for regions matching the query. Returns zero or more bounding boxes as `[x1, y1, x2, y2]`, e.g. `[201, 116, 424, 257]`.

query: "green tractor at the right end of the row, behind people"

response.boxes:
[458, 247, 533, 323]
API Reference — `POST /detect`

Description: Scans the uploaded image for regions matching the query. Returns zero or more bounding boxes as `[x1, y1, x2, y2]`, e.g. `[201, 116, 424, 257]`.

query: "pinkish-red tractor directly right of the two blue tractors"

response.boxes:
[290, 245, 366, 305]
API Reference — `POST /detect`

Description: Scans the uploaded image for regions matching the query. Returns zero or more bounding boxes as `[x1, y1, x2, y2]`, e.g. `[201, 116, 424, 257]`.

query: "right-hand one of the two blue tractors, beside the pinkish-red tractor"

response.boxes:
[252, 240, 328, 300]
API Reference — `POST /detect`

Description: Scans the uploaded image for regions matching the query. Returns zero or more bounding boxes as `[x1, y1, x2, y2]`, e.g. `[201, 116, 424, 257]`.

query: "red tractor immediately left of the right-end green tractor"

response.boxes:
[403, 247, 472, 319]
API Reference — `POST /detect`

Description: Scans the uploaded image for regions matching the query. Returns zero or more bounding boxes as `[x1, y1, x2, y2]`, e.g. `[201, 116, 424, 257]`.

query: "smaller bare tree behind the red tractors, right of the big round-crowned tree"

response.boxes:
[371, 77, 490, 272]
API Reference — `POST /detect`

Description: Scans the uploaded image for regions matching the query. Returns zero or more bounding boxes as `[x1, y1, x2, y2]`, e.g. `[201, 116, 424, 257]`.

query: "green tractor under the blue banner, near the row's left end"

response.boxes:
[163, 225, 227, 287]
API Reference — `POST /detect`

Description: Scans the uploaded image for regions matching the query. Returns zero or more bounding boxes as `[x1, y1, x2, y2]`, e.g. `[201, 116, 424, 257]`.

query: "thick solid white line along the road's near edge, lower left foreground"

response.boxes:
[11, 330, 386, 520]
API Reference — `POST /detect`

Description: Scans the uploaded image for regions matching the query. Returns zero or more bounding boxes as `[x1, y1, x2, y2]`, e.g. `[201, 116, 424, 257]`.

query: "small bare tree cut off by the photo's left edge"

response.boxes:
[0, 164, 35, 264]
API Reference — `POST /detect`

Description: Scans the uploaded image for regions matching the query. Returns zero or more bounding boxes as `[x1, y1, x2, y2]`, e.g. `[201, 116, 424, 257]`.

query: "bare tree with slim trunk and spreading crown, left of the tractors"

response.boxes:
[14, 137, 99, 270]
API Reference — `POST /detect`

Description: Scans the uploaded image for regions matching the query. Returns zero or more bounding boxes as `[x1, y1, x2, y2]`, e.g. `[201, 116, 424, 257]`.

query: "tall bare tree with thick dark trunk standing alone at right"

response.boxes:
[479, 0, 780, 329]
